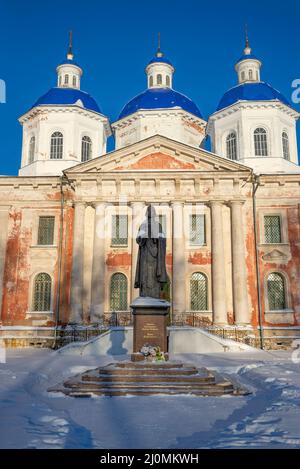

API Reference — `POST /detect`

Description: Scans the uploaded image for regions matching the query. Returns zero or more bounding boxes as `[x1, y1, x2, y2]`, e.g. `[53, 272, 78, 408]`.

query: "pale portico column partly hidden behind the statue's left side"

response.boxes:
[131, 202, 145, 301]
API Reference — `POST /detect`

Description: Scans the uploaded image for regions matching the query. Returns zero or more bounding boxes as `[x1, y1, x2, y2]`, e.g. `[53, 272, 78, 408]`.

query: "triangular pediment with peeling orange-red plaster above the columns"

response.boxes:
[65, 135, 251, 175]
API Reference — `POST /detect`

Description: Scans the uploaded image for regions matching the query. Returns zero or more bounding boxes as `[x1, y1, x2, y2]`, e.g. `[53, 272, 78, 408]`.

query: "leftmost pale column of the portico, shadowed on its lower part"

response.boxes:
[70, 202, 85, 323]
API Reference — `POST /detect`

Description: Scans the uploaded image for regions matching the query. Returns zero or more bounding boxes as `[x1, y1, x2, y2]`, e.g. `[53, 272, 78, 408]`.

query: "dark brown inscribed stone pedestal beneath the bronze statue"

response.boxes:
[130, 297, 170, 361]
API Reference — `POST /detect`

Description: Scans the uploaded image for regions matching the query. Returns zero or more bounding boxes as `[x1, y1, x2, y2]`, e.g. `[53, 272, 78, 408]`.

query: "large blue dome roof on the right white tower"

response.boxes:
[217, 81, 291, 111]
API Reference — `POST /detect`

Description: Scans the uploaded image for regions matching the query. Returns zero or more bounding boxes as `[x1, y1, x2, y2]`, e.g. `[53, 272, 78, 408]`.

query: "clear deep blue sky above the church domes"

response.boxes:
[0, 0, 300, 175]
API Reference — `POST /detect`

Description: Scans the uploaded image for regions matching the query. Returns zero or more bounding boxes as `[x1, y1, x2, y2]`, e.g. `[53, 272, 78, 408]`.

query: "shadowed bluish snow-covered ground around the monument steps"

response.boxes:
[0, 349, 300, 449]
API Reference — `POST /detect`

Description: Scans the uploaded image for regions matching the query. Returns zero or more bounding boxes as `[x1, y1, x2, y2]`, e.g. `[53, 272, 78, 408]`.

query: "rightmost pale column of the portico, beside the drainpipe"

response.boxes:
[230, 200, 250, 325]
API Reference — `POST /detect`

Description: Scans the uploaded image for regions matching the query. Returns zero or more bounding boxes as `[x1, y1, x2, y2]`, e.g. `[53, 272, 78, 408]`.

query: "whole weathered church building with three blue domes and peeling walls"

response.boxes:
[0, 36, 300, 348]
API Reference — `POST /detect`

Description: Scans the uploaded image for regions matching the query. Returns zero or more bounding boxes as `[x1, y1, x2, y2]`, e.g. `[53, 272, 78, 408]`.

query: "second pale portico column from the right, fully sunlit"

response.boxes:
[210, 200, 227, 325]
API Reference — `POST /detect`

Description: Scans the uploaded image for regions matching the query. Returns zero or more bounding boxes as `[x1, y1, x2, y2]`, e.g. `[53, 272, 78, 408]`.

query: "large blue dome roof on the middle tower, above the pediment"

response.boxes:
[119, 88, 202, 119]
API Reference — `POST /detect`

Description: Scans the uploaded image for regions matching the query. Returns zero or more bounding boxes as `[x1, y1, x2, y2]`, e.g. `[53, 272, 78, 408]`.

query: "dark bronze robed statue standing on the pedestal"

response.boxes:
[134, 205, 168, 298]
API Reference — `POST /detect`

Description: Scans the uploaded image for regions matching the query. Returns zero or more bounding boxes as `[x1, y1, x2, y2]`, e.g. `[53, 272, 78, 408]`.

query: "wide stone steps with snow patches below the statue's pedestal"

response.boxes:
[48, 361, 249, 397]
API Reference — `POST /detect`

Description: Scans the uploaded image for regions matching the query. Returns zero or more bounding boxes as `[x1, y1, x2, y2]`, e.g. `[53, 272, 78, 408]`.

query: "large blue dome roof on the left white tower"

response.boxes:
[33, 87, 102, 114]
